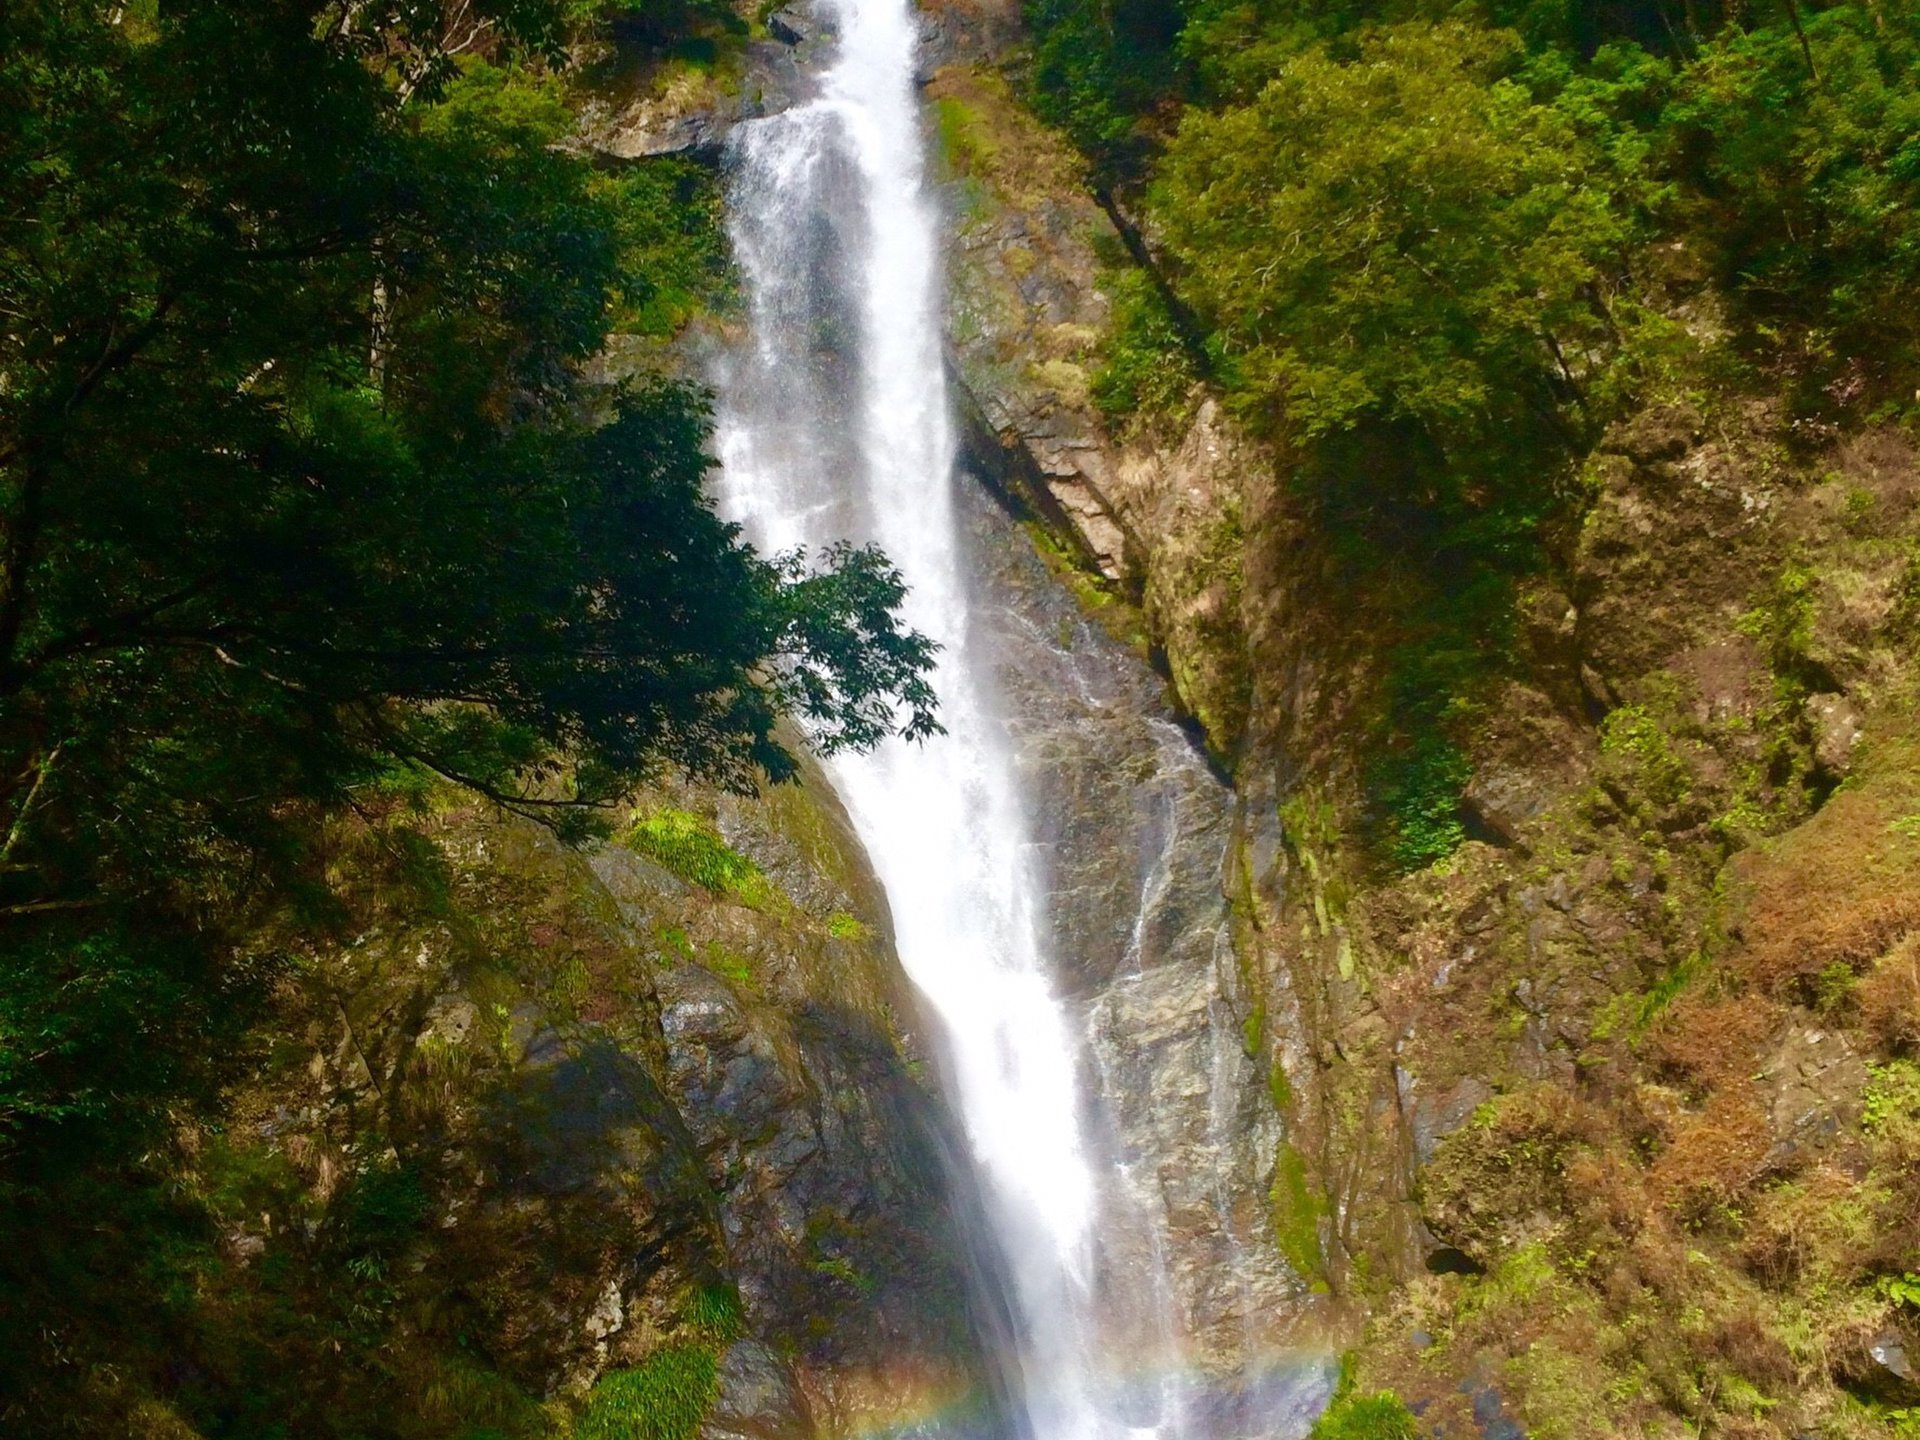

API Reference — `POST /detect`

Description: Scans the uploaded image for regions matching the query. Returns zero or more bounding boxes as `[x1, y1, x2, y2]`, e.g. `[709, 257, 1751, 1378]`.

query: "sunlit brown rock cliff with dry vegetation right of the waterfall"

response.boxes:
[929, 28, 1920, 1436]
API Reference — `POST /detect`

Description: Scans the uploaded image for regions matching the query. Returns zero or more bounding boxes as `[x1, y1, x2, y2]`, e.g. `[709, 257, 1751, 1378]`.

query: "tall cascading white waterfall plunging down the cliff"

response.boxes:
[716, 0, 1175, 1440]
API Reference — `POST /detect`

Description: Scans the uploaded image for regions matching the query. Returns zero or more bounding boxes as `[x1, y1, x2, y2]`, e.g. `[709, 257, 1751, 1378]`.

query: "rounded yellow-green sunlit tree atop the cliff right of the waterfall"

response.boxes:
[1156, 23, 1658, 499]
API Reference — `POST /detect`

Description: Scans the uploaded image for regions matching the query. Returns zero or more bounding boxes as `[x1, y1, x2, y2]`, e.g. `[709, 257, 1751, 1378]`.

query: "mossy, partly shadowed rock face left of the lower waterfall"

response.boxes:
[204, 776, 1021, 1440]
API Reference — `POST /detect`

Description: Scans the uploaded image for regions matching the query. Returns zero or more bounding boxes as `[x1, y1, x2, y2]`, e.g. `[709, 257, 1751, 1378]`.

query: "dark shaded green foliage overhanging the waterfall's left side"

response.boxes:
[0, 0, 933, 1436]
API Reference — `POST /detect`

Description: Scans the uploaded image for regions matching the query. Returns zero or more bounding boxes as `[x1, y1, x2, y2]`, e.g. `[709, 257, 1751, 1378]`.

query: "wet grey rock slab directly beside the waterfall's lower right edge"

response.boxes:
[962, 488, 1317, 1405]
